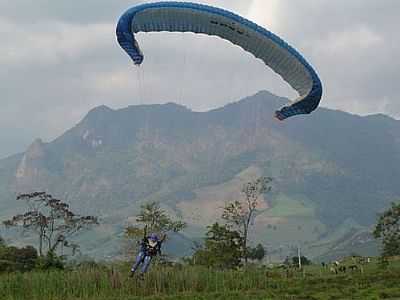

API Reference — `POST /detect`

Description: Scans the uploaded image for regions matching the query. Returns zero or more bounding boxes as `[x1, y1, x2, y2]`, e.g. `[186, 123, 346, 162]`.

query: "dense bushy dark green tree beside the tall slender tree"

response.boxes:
[192, 223, 243, 269]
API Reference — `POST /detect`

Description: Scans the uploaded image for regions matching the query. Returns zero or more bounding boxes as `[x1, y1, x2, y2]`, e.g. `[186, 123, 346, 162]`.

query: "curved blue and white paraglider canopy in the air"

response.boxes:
[116, 2, 322, 120]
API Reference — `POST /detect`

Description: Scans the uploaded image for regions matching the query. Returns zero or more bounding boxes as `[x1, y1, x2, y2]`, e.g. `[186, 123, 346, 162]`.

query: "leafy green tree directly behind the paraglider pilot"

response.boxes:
[125, 202, 186, 255]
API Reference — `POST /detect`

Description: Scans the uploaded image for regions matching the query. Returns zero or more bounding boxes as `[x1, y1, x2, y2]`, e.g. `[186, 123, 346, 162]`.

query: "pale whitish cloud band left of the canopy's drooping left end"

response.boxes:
[0, 19, 114, 68]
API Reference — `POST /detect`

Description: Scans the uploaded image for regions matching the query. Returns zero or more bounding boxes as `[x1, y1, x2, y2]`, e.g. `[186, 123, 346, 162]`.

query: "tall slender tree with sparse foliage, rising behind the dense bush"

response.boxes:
[222, 177, 272, 263]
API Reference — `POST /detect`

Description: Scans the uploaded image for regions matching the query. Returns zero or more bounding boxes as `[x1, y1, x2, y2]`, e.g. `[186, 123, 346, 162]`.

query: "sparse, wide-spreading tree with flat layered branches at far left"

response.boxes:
[3, 192, 98, 256]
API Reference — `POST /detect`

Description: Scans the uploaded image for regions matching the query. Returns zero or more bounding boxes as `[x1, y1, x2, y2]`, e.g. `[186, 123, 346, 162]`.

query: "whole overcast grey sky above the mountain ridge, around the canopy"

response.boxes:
[0, 0, 400, 158]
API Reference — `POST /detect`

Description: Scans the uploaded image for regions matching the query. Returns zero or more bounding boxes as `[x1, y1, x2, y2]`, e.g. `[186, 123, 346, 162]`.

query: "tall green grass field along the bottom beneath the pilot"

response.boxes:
[0, 261, 400, 300]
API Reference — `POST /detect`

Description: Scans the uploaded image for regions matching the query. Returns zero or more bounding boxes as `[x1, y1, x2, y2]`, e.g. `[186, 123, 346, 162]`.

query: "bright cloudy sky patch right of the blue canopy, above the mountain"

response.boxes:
[249, 0, 400, 118]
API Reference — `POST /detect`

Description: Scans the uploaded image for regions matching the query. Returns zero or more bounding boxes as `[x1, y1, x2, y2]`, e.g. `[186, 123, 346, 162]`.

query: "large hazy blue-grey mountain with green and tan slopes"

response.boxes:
[0, 91, 400, 258]
